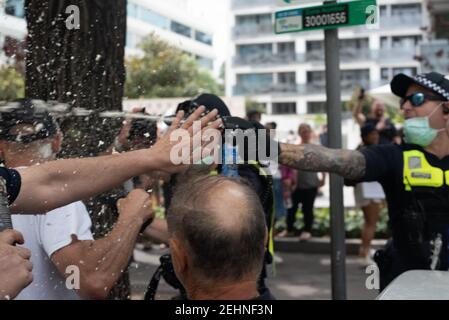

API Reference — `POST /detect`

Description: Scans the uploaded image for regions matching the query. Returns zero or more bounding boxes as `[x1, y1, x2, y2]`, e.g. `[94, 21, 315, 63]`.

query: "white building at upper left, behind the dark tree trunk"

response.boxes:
[0, 0, 219, 74]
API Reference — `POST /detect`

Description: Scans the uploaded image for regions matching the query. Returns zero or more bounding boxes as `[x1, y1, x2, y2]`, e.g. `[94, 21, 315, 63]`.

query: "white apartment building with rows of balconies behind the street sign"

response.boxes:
[226, 0, 430, 120]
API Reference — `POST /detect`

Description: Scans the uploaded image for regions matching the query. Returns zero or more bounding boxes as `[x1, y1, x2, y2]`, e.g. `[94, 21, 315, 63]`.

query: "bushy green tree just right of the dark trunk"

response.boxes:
[125, 34, 223, 99]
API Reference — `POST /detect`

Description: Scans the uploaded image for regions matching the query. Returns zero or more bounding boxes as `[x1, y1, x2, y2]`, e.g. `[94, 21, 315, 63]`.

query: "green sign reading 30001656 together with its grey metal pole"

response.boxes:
[274, 0, 377, 300]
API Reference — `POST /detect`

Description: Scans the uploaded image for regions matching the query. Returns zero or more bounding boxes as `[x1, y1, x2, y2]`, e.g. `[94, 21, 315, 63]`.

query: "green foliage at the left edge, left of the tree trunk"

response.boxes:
[0, 65, 25, 101]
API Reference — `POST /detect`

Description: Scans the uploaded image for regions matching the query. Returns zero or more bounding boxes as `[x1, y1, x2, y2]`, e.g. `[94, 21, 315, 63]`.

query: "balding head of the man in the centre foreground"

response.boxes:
[167, 170, 266, 285]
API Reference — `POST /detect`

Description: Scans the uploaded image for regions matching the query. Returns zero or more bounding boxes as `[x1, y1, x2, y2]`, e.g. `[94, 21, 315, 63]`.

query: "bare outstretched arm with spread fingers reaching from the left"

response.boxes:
[11, 108, 221, 214]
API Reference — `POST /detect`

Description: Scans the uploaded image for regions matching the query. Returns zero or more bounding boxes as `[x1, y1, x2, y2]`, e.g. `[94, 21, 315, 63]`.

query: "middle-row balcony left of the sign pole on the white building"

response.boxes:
[234, 52, 304, 66]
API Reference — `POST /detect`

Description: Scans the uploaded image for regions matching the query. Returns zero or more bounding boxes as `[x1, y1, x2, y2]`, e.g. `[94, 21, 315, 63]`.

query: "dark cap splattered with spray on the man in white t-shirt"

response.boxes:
[0, 99, 59, 143]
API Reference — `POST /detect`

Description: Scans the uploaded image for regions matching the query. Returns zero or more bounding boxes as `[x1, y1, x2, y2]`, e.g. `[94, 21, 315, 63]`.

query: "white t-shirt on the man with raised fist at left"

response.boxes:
[12, 202, 93, 300]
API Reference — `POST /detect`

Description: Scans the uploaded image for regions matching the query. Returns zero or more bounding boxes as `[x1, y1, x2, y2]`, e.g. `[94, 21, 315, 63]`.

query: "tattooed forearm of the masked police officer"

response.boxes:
[279, 144, 366, 180]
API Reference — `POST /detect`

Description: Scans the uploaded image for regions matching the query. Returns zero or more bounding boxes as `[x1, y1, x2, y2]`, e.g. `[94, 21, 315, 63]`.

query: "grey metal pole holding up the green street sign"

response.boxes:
[324, 10, 346, 300]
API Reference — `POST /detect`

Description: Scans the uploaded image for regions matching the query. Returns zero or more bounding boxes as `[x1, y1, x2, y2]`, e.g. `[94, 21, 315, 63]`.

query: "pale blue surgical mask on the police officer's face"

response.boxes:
[404, 104, 445, 147]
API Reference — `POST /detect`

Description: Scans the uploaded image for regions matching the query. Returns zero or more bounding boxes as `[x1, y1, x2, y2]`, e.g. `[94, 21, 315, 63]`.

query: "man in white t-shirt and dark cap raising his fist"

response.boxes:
[0, 106, 154, 299]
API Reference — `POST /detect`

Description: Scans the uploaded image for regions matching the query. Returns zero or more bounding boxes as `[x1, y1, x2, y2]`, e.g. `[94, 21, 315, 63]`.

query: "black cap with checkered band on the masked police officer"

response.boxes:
[390, 72, 449, 101]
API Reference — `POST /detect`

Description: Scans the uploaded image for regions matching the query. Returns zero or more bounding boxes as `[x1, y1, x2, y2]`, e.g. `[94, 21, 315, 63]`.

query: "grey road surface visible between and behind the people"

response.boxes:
[130, 247, 378, 300]
